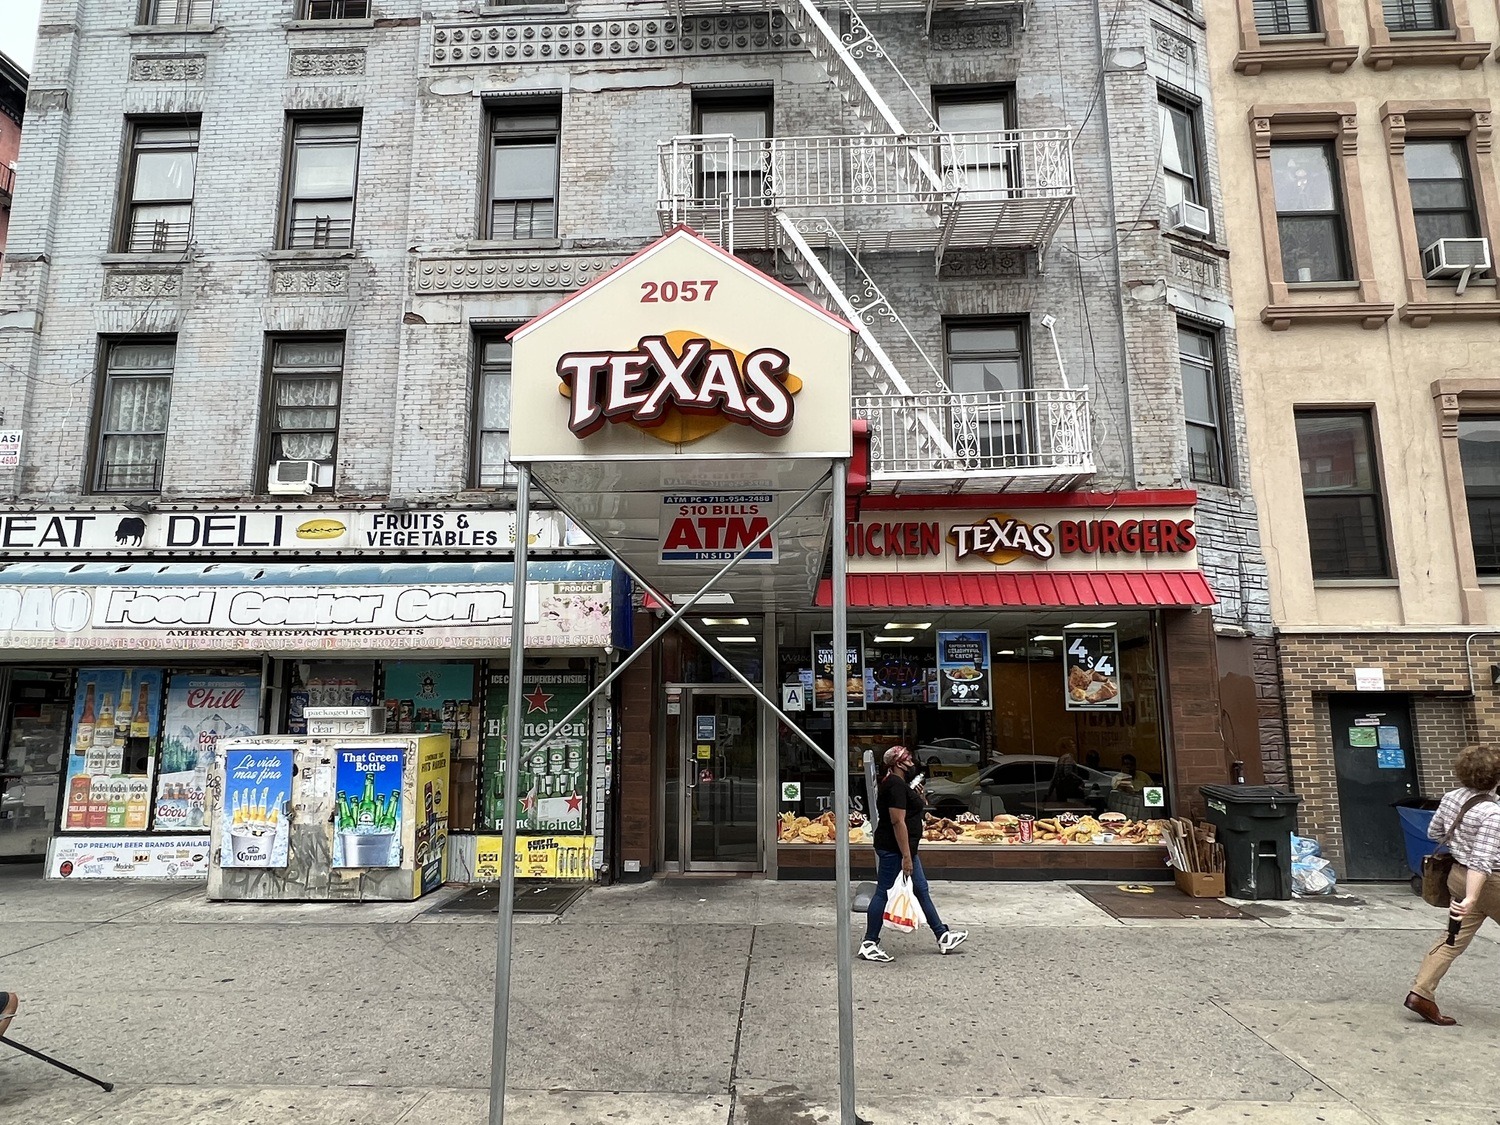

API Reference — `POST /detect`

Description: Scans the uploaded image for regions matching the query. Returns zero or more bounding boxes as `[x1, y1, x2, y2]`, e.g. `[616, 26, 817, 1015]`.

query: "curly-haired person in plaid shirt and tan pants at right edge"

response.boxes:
[1406, 746, 1500, 1028]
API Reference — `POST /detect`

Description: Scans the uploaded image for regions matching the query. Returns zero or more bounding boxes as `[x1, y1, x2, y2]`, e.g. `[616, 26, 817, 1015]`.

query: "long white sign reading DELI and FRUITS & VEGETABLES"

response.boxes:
[0, 507, 590, 558]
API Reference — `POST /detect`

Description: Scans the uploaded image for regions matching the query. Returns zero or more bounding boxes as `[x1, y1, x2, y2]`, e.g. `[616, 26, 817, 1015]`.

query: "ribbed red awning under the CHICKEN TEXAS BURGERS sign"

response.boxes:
[818, 570, 1218, 609]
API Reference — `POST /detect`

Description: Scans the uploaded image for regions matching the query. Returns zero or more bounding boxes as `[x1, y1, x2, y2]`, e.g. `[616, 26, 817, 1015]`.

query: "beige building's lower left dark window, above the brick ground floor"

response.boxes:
[1296, 411, 1391, 578]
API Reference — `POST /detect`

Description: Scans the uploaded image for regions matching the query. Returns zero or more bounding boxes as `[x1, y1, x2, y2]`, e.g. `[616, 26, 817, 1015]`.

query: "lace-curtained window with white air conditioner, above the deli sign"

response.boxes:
[267, 336, 344, 489]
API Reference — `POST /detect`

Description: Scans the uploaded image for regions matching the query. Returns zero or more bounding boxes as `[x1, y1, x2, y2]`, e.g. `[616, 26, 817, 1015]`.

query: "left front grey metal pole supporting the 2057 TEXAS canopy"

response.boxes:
[489, 465, 531, 1125]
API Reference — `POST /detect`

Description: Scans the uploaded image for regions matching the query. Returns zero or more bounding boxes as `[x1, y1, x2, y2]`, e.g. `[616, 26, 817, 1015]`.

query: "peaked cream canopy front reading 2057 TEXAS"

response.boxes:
[510, 227, 852, 462]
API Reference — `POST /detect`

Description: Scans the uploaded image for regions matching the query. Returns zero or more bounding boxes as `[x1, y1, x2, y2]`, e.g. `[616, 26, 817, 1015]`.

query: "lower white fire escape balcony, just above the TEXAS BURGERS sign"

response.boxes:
[854, 387, 1095, 494]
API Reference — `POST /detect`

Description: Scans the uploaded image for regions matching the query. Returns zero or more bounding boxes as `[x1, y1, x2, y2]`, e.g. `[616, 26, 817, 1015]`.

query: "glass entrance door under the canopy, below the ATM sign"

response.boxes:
[678, 687, 764, 872]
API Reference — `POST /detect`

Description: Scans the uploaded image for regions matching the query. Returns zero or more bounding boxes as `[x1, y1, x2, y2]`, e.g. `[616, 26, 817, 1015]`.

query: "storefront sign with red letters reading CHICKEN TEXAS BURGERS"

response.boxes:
[846, 504, 1199, 573]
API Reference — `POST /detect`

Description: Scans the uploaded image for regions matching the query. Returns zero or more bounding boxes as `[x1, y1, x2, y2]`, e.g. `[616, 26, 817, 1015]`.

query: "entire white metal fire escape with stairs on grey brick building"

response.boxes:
[657, 0, 1094, 492]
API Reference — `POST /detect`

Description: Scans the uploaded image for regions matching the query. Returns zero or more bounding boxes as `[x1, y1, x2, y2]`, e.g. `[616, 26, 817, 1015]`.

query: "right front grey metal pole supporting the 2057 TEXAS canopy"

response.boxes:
[830, 461, 858, 1125]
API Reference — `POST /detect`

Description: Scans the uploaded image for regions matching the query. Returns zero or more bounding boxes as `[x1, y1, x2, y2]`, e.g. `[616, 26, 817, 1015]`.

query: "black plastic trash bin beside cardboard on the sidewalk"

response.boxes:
[1199, 785, 1302, 899]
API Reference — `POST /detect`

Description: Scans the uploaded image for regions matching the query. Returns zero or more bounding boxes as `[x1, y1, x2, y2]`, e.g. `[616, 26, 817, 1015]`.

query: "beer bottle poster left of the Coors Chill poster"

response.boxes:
[63, 668, 165, 833]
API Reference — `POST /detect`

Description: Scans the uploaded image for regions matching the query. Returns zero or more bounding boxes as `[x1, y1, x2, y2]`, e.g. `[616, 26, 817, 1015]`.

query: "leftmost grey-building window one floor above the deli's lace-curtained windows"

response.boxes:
[120, 123, 198, 254]
